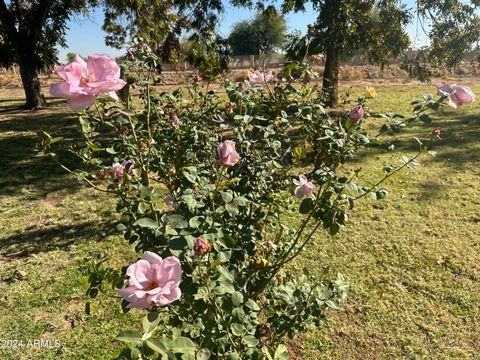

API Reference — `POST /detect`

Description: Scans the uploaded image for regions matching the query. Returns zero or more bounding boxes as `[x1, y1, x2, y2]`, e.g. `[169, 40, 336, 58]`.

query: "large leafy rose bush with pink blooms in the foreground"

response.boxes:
[40, 44, 472, 359]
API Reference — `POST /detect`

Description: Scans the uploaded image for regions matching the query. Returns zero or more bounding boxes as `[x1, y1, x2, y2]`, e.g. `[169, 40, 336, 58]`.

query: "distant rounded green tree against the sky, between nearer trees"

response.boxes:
[228, 6, 287, 55]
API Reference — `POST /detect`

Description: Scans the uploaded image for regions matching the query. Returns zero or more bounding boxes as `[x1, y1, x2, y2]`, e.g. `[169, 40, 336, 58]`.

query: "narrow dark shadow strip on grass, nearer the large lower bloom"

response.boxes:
[0, 222, 113, 260]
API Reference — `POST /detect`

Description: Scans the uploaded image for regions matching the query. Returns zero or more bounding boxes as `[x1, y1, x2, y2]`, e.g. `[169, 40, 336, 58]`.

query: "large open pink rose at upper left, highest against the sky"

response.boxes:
[50, 55, 126, 110]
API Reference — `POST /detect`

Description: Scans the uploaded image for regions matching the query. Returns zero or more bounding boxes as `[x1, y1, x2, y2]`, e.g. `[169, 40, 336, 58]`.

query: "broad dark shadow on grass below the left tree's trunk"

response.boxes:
[0, 105, 81, 200]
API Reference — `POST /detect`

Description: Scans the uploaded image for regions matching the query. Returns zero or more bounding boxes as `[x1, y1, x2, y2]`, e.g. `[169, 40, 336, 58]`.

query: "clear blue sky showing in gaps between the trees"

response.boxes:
[59, 0, 427, 62]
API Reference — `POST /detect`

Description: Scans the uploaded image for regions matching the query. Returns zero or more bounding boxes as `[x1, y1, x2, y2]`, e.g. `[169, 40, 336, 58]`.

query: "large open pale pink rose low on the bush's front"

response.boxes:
[118, 251, 182, 309]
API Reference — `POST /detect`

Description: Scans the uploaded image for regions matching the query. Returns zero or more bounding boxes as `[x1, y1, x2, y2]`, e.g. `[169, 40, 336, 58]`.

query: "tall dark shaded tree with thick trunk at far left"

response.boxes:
[0, 0, 96, 108]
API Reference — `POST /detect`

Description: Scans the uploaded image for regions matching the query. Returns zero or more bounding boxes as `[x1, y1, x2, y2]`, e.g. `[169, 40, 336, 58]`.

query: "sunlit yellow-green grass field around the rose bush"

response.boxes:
[0, 85, 480, 360]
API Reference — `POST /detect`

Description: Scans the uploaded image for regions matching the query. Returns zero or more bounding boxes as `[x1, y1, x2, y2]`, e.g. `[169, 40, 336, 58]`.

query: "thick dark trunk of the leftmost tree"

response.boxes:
[19, 58, 47, 109]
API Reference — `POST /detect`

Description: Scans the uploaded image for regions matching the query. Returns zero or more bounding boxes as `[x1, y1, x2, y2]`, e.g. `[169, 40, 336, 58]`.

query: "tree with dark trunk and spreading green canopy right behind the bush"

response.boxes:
[283, 0, 410, 107]
